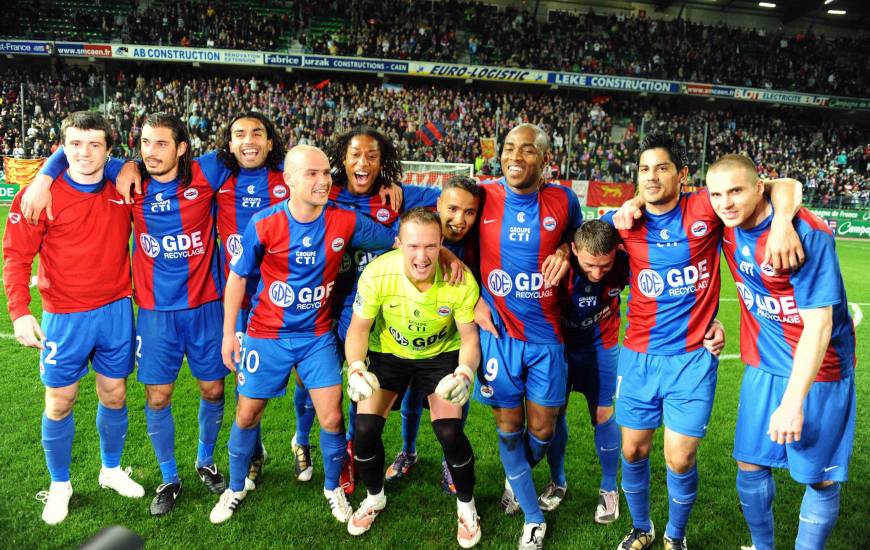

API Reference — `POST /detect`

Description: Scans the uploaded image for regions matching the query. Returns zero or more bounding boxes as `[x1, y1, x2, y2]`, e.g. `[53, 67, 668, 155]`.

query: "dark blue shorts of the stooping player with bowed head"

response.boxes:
[567, 344, 619, 407]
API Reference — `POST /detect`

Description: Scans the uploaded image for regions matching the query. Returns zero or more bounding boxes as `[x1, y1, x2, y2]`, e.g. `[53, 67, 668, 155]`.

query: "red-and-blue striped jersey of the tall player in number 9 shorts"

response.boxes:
[478, 178, 583, 344]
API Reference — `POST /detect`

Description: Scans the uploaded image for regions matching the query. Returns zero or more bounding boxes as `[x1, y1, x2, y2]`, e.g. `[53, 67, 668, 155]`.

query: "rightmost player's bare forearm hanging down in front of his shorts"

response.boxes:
[767, 306, 834, 445]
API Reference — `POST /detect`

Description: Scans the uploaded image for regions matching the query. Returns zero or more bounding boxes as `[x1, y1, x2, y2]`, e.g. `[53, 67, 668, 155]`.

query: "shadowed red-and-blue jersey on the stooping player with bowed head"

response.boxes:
[562, 250, 628, 349]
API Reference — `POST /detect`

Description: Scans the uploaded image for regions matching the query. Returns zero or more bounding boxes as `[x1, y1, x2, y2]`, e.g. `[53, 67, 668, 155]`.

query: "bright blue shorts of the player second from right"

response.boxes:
[616, 346, 719, 437]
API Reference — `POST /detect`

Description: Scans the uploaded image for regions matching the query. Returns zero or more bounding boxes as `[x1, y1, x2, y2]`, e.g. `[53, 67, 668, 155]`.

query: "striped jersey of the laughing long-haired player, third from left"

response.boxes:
[217, 166, 290, 309]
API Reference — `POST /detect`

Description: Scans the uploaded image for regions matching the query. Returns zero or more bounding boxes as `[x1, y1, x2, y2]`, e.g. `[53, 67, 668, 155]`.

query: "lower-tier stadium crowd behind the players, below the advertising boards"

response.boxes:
[0, 69, 870, 207]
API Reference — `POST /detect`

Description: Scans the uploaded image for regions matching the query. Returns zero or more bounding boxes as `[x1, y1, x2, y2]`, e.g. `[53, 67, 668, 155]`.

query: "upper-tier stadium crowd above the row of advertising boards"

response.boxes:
[0, 0, 870, 96]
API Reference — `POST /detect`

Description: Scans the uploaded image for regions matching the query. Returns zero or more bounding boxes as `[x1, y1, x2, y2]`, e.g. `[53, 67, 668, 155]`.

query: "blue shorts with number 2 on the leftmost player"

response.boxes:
[39, 298, 134, 388]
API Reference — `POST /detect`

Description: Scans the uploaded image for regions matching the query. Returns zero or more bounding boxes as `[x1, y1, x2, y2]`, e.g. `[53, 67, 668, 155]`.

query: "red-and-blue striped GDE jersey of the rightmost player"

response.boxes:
[723, 208, 855, 382]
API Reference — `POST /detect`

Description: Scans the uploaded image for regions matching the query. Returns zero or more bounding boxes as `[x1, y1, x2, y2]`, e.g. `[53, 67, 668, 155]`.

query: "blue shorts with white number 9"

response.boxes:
[474, 330, 568, 409]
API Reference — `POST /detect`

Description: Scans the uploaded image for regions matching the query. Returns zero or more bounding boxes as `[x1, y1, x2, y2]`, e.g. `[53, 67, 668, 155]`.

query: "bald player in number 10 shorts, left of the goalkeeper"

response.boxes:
[210, 145, 395, 523]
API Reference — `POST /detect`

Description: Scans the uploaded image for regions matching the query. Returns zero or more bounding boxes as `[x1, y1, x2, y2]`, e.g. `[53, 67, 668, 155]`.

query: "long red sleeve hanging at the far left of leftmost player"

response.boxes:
[3, 193, 46, 321]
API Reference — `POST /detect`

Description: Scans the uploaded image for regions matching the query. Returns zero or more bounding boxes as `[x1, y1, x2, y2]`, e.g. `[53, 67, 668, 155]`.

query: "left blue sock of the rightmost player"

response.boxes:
[737, 468, 776, 550]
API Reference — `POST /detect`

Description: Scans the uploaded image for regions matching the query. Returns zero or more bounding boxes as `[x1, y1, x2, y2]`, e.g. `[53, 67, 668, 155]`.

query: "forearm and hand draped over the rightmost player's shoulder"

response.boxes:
[764, 178, 805, 271]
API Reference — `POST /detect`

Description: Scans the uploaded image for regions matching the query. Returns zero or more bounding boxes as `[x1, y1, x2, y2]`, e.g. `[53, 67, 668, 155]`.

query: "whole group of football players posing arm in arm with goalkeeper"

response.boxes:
[3, 112, 856, 550]
